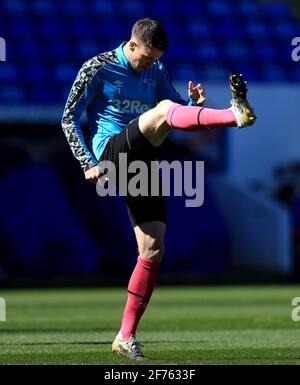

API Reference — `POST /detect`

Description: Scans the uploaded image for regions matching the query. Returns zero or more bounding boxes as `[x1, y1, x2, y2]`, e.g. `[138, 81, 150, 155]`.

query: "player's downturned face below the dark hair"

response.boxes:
[131, 42, 163, 71]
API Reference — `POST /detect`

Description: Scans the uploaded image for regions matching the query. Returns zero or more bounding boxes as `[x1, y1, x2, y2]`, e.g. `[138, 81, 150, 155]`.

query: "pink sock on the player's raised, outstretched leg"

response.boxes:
[167, 103, 237, 131]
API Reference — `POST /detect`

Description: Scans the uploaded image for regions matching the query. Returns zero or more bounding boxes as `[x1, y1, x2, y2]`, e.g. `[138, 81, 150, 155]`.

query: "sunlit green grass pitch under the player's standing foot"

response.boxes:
[0, 286, 300, 365]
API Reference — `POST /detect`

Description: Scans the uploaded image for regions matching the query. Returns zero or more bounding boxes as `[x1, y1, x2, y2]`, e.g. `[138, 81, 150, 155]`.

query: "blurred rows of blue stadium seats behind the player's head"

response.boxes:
[0, 0, 300, 104]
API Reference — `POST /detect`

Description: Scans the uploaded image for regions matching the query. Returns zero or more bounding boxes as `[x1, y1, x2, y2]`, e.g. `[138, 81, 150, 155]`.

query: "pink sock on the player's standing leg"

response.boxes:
[120, 257, 160, 339]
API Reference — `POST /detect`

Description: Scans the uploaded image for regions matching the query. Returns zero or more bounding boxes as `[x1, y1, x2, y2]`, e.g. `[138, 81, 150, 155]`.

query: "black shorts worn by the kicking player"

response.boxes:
[99, 118, 167, 227]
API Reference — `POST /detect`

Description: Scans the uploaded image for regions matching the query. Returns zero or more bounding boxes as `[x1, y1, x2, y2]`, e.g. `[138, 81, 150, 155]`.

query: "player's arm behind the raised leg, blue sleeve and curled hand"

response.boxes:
[158, 63, 206, 106]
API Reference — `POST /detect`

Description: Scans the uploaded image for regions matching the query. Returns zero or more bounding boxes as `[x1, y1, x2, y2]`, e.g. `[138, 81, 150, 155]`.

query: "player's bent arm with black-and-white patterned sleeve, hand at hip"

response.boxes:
[61, 61, 100, 181]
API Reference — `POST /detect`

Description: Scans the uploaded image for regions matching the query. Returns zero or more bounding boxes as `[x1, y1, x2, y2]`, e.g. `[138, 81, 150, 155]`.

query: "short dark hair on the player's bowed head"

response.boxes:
[131, 17, 169, 51]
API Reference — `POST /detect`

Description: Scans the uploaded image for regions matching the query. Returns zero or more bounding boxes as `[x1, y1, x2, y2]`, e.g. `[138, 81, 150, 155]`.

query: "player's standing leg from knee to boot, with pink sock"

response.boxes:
[112, 221, 166, 360]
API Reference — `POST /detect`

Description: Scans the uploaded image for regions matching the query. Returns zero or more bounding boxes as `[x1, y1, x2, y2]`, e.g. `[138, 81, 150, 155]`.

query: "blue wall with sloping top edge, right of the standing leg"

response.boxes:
[210, 172, 294, 275]
